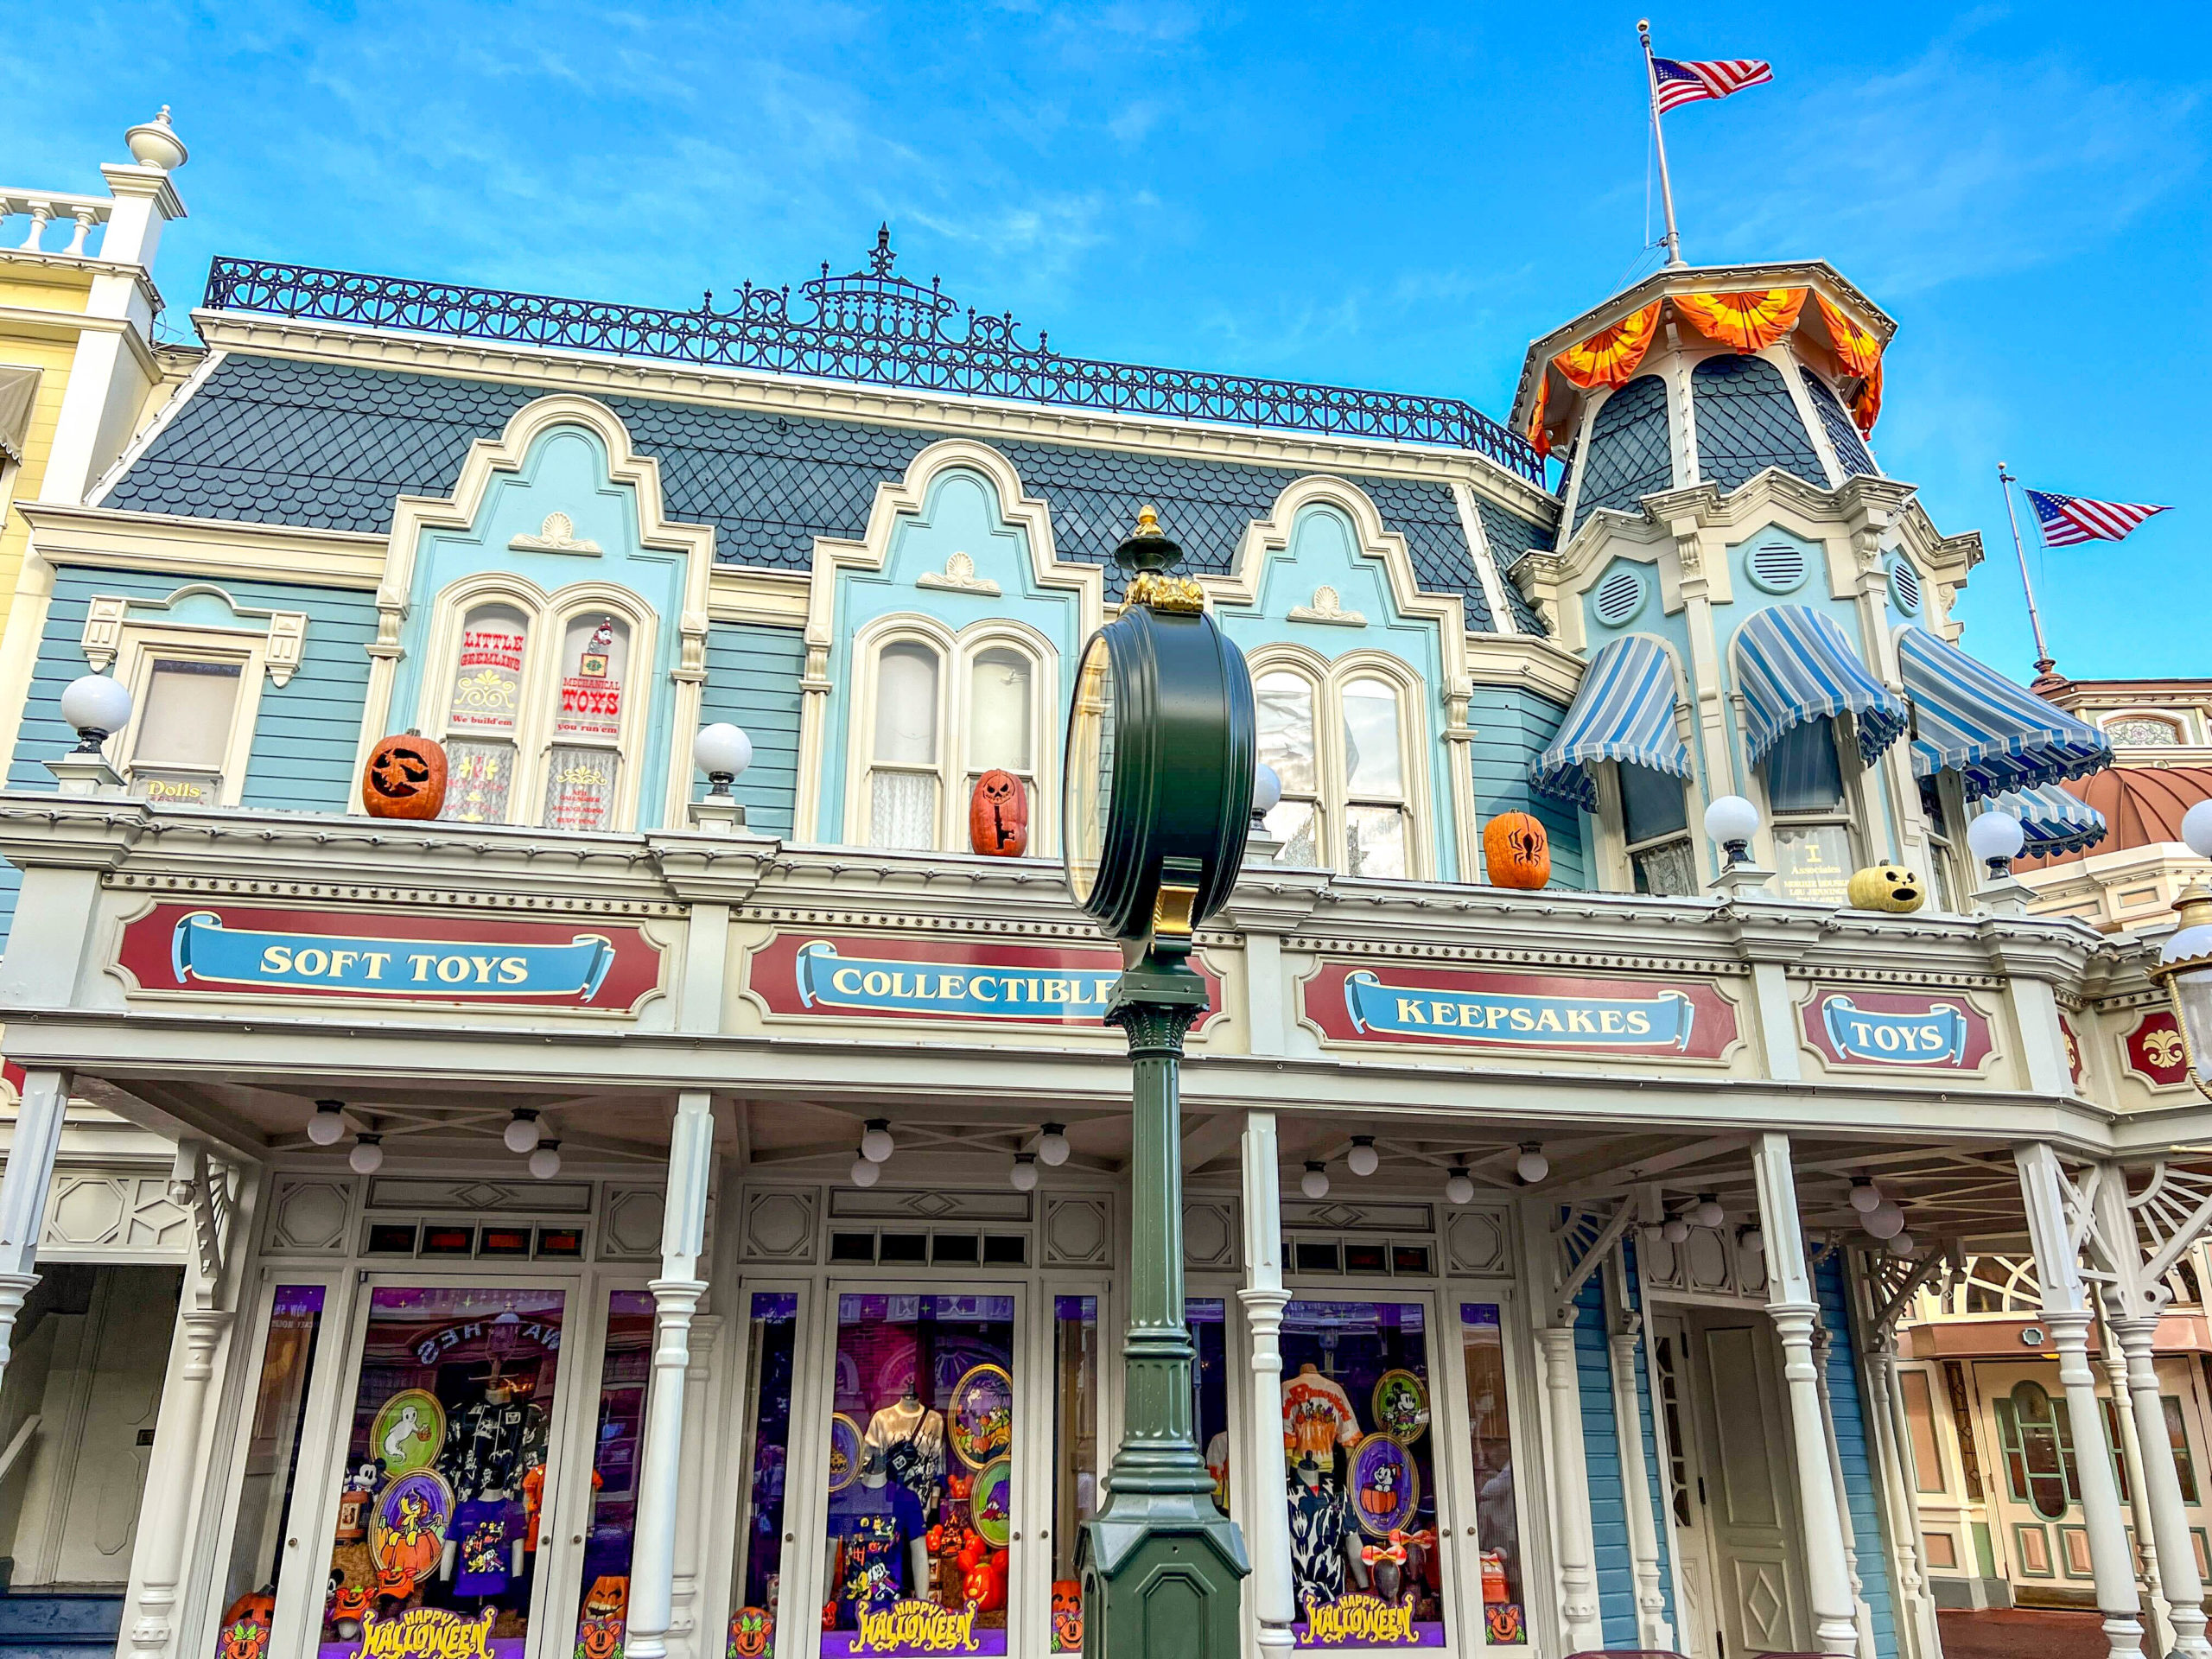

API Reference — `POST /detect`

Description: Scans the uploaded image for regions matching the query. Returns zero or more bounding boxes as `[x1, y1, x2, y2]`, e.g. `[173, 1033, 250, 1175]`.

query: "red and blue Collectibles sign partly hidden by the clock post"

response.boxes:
[746, 933, 1221, 1027]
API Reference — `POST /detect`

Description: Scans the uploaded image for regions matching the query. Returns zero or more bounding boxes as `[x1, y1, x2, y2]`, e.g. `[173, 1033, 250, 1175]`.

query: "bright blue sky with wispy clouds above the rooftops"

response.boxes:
[0, 0, 2212, 677]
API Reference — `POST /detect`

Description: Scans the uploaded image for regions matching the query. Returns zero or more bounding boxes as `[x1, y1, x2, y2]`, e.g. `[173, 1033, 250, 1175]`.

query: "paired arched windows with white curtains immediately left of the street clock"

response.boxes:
[849, 617, 1053, 854]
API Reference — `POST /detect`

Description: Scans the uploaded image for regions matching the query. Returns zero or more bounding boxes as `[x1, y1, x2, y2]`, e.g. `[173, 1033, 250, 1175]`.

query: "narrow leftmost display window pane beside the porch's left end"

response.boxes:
[214, 1285, 325, 1659]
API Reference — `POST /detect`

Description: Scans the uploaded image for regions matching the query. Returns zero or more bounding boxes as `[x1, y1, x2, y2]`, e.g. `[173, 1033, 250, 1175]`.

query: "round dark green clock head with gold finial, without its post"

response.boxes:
[1059, 506, 1256, 943]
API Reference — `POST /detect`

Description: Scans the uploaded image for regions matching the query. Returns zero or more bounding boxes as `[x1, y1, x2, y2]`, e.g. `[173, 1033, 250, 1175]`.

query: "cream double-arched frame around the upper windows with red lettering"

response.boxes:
[414, 573, 659, 834]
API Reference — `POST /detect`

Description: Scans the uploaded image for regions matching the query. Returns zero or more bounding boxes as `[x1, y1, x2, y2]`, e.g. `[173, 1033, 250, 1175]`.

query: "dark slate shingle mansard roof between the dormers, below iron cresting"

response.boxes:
[102, 356, 1551, 632]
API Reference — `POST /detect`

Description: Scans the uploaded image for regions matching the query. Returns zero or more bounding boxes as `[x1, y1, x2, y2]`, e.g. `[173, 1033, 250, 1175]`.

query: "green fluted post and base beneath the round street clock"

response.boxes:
[1077, 944, 1252, 1659]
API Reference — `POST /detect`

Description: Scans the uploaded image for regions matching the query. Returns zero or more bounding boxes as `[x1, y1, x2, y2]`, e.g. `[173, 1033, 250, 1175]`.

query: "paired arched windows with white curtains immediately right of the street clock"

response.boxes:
[1252, 657, 1421, 876]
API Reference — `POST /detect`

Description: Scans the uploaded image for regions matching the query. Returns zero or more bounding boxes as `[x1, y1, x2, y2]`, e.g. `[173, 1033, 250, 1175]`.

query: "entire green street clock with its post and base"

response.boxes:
[1062, 506, 1256, 1659]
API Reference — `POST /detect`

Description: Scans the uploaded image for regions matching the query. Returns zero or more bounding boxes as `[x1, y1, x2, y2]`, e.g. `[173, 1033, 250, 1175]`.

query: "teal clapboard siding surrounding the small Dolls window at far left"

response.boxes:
[0, 566, 376, 933]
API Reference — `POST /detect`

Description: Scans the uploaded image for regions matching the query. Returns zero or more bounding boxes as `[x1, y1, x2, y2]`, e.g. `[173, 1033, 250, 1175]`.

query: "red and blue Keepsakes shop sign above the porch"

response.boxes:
[1300, 963, 1738, 1059]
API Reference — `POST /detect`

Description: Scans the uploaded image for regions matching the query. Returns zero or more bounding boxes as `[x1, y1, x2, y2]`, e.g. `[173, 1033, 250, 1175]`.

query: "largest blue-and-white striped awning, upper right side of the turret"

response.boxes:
[1897, 624, 2113, 801]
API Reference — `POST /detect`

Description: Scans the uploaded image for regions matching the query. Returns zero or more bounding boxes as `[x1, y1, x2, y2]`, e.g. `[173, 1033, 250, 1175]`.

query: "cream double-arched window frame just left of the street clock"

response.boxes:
[845, 615, 1059, 858]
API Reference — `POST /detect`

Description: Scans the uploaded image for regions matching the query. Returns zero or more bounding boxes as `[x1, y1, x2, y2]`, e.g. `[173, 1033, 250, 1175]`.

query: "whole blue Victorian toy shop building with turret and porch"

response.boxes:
[0, 123, 2212, 1659]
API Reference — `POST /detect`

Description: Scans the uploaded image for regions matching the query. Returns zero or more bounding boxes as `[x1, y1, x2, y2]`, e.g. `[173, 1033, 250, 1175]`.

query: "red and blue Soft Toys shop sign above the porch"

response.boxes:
[115, 905, 661, 1013]
